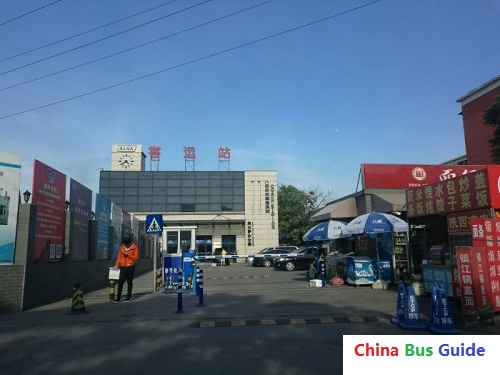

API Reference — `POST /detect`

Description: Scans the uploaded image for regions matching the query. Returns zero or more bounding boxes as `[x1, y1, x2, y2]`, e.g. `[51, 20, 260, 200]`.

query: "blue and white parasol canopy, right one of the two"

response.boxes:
[345, 212, 408, 234]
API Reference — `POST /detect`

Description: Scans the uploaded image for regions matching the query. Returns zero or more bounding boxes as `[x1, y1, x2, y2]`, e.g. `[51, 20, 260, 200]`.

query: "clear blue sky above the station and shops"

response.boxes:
[0, 0, 500, 203]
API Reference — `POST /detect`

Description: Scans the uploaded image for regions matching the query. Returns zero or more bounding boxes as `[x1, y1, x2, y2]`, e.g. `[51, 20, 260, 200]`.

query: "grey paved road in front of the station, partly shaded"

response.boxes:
[0, 263, 494, 375]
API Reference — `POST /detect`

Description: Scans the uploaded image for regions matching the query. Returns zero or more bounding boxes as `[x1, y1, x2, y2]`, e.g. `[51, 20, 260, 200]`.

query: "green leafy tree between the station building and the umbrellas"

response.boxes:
[278, 185, 331, 246]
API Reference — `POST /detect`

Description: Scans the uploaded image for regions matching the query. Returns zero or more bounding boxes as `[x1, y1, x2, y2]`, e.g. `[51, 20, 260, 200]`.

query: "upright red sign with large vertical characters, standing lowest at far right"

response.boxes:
[457, 247, 491, 314]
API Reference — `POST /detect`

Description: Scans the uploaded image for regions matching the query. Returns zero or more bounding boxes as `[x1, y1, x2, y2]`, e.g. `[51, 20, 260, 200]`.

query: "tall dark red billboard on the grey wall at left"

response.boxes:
[31, 160, 66, 263]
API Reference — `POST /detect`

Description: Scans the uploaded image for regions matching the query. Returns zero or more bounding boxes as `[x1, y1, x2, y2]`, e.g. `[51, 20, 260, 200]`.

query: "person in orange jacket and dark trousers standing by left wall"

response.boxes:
[113, 237, 139, 303]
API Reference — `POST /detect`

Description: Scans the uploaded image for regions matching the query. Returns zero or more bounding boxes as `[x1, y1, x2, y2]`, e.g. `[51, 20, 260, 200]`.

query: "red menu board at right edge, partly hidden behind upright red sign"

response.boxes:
[471, 219, 500, 312]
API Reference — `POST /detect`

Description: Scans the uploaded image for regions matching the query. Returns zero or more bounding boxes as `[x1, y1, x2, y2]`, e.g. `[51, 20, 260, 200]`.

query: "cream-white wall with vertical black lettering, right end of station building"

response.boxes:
[245, 171, 279, 254]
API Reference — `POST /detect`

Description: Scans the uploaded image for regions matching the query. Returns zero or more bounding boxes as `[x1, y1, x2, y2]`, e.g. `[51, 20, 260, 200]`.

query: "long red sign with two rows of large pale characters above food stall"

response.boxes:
[406, 165, 500, 218]
